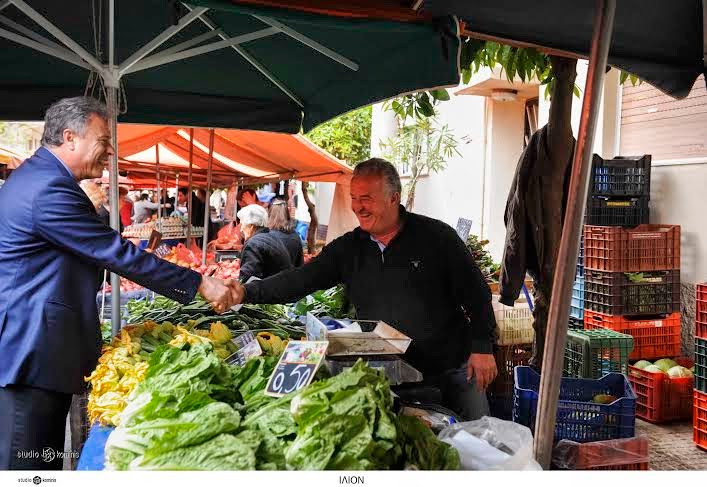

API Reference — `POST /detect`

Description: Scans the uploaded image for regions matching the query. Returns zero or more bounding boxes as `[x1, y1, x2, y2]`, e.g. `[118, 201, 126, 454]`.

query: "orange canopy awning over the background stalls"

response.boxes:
[118, 124, 352, 187]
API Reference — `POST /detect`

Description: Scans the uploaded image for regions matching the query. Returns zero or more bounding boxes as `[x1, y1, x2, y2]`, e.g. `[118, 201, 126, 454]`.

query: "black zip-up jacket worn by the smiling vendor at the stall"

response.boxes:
[245, 206, 496, 374]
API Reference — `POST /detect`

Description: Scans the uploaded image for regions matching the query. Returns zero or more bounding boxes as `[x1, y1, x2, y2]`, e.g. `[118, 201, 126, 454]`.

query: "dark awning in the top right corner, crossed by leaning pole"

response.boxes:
[424, 0, 705, 98]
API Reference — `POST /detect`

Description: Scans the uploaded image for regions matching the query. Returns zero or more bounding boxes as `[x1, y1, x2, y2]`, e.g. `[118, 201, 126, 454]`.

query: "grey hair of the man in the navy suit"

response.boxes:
[42, 96, 108, 147]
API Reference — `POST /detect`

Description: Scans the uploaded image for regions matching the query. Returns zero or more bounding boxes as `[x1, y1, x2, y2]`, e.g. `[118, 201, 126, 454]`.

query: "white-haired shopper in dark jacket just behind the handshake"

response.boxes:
[238, 205, 292, 282]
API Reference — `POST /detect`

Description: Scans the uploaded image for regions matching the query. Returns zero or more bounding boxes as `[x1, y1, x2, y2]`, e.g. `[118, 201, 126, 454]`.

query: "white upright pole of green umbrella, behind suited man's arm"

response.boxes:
[106, 86, 121, 336]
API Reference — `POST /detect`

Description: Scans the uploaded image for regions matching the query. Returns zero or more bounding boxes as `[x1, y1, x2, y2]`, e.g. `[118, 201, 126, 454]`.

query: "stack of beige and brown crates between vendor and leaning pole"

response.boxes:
[487, 296, 535, 420]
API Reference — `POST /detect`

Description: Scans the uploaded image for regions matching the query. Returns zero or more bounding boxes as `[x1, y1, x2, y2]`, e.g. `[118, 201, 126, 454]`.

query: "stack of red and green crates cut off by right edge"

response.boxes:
[692, 283, 707, 450]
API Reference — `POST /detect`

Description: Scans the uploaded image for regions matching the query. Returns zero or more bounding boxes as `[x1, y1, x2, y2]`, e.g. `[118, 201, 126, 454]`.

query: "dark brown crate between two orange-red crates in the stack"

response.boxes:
[584, 269, 680, 316]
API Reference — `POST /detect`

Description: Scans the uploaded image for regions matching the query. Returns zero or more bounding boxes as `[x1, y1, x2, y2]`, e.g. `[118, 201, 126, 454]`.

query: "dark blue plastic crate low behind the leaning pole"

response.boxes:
[513, 367, 636, 443]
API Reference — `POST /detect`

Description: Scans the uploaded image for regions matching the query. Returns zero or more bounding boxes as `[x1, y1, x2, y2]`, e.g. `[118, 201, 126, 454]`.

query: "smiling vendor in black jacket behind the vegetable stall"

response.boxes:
[232, 159, 497, 420]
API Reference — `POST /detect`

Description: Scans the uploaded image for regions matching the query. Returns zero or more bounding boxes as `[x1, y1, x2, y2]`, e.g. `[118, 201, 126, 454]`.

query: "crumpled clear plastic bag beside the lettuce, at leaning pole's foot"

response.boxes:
[439, 416, 542, 470]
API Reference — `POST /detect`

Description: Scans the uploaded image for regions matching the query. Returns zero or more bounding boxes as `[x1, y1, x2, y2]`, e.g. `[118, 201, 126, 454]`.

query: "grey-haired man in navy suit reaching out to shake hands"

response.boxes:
[0, 97, 235, 470]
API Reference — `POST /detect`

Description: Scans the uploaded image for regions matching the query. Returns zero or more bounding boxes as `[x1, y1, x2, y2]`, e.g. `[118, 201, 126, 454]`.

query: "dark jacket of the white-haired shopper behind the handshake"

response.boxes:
[240, 228, 292, 282]
